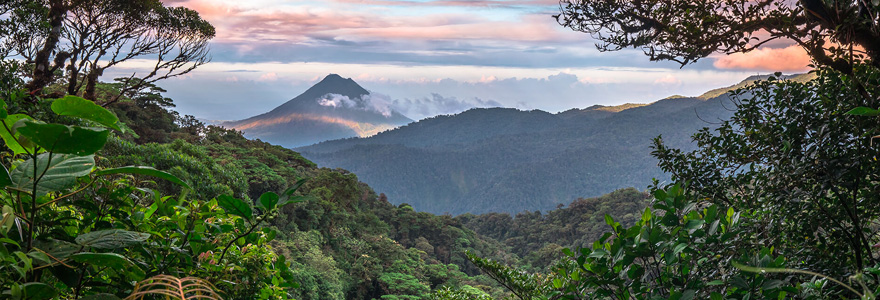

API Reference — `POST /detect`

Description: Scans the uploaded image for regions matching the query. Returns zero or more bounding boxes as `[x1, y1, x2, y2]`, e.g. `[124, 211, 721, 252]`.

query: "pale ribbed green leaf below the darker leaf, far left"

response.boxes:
[9, 153, 95, 197]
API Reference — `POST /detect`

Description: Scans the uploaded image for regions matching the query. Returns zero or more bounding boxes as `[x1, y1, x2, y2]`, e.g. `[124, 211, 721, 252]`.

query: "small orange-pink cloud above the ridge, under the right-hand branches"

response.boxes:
[714, 46, 810, 72]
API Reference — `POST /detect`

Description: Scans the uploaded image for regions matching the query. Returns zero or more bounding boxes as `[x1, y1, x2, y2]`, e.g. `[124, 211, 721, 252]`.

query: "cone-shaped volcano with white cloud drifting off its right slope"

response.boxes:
[221, 74, 412, 147]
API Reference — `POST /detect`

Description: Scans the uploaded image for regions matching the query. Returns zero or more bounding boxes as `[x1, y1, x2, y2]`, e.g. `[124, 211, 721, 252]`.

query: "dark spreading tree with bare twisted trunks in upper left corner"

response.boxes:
[0, 0, 215, 102]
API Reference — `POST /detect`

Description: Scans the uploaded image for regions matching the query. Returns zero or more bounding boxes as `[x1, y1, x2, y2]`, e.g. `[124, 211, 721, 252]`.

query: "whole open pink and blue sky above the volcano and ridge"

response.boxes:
[122, 0, 809, 120]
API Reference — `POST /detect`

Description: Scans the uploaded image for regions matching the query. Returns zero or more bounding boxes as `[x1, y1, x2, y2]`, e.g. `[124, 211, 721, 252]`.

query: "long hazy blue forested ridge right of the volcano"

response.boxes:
[295, 75, 809, 215]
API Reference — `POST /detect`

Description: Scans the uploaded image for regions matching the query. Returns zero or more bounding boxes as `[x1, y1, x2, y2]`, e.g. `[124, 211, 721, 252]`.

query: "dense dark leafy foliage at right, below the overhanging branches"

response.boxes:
[655, 67, 880, 277]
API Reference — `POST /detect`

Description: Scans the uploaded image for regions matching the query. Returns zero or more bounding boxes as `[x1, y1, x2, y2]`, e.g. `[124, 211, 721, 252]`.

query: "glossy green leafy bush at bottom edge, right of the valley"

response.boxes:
[551, 185, 797, 299]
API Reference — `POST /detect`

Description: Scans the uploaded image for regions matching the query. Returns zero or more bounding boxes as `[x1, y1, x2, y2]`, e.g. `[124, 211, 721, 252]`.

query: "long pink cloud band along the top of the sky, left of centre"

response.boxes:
[168, 0, 572, 43]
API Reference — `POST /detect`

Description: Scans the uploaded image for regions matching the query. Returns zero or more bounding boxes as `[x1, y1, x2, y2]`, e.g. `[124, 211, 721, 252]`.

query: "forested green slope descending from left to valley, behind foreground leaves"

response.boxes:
[101, 84, 519, 299]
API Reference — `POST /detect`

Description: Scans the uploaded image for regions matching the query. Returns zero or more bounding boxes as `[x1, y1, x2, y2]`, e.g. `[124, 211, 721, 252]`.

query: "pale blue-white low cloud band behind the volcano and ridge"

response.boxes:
[129, 61, 756, 120]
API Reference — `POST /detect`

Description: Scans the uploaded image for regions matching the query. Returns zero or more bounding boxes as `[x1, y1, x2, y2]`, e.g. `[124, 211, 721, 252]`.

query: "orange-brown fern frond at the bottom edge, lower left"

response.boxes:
[125, 275, 223, 300]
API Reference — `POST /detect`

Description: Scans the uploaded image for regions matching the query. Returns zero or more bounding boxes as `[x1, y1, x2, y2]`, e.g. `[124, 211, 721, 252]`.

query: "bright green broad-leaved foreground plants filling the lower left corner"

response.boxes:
[0, 84, 301, 299]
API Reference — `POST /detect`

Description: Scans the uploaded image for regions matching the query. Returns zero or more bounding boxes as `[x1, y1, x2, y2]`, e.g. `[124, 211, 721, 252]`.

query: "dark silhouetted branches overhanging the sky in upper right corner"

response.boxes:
[555, 0, 880, 104]
